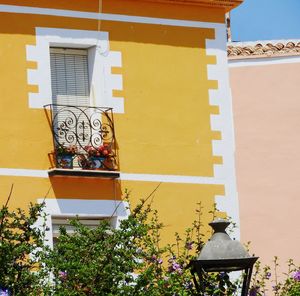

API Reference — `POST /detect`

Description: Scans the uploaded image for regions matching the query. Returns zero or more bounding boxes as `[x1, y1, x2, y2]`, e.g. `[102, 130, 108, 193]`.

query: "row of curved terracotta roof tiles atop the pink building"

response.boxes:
[227, 41, 300, 58]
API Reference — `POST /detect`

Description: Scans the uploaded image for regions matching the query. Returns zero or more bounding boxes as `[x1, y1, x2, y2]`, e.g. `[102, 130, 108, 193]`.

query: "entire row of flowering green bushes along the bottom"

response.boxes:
[0, 190, 300, 296]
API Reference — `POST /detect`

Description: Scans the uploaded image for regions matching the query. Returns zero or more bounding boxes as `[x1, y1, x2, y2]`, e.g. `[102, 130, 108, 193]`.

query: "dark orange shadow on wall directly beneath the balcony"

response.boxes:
[50, 176, 122, 200]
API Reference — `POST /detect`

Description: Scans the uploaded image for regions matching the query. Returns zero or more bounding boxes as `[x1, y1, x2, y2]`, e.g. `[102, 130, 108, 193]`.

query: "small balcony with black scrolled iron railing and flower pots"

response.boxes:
[44, 104, 119, 178]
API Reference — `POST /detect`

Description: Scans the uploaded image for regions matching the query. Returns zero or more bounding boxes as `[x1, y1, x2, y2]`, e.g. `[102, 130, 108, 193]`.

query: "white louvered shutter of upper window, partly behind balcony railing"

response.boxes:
[50, 48, 90, 151]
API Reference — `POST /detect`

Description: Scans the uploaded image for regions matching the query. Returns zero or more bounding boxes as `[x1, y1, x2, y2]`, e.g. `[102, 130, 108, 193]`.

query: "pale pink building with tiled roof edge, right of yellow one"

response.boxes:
[228, 41, 300, 266]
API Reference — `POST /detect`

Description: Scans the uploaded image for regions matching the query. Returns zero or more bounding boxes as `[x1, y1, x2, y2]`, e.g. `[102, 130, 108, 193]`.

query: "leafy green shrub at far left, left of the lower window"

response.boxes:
[0, 197, 45, 295]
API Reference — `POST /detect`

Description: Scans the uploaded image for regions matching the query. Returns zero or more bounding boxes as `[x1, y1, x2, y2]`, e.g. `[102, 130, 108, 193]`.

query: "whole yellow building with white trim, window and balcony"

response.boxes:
[0, 0, 242, 244]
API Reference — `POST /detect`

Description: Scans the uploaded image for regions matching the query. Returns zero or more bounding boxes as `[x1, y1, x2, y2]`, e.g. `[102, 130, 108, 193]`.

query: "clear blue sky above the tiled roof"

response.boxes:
[231, 0, 300, 41]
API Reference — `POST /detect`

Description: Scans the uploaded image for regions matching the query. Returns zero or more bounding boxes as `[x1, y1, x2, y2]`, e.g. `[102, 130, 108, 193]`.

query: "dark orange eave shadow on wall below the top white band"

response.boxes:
[1, 13, 215, 50]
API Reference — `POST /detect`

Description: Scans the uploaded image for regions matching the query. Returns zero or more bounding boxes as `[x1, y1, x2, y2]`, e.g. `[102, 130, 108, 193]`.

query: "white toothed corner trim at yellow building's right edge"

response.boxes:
[206, 26, 240, 238]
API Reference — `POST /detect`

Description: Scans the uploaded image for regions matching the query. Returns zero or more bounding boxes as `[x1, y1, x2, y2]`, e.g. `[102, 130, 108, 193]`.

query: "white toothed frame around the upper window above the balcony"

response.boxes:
[26, 27, 124, 113]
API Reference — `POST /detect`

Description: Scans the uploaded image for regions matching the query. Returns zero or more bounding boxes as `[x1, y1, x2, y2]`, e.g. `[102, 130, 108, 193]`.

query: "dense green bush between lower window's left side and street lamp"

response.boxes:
[45, 201, 199, 296]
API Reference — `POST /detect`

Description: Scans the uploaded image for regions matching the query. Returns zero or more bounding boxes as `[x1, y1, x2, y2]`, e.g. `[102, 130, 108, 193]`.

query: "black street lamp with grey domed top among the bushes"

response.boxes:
[189, 219, 258, 296]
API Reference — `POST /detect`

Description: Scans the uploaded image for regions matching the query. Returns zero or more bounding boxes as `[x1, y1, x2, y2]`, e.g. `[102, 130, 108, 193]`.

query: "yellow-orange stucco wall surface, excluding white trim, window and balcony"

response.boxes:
[0, 0, 232, 244]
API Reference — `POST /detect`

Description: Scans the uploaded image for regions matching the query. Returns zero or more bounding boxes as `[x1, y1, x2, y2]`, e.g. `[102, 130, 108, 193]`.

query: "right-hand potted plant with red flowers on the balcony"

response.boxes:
[84, 143, 112, 169]
